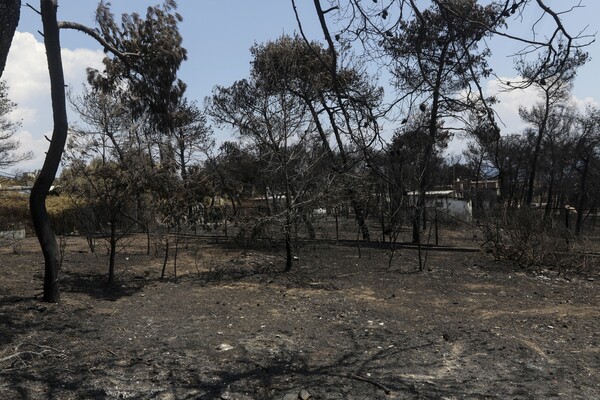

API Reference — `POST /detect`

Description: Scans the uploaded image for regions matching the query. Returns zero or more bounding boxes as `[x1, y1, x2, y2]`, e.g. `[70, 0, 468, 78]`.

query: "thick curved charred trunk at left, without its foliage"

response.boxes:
[29, 0, 68, 303]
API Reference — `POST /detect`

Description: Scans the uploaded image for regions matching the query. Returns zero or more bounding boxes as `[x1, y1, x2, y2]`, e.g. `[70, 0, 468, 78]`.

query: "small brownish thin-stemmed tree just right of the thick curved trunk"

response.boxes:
[66, 87, 151, 284]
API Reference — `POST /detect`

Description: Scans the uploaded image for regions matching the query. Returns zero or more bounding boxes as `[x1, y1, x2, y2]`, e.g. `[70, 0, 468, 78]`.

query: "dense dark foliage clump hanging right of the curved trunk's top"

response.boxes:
[88, 0, 187, 130]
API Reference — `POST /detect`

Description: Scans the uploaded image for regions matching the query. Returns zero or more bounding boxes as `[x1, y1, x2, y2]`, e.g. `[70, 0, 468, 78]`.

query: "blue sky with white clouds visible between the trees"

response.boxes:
[2, 0, 600, 170]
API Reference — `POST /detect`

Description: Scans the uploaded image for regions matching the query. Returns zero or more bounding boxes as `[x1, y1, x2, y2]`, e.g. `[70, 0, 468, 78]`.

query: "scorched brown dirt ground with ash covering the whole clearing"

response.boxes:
[0, 234, 600, 400]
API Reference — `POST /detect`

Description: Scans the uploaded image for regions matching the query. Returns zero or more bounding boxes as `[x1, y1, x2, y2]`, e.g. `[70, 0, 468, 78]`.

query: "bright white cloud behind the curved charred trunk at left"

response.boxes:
[2, 32, 104, 174]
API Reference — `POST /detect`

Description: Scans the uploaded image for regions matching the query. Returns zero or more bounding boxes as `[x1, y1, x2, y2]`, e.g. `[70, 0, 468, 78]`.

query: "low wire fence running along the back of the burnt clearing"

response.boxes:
[0, 200, 600, 250]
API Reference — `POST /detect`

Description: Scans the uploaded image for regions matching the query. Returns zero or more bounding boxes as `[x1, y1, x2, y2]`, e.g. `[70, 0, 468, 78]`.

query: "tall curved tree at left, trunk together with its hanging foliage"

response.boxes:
[22, 0, 186, 302]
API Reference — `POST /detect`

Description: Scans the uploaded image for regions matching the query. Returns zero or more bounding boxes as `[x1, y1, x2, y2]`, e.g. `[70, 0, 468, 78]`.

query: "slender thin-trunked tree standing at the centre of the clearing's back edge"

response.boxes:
[209, 39, 326, 271]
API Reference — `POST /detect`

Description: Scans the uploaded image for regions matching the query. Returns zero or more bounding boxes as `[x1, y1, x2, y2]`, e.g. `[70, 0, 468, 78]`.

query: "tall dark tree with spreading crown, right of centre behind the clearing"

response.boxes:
[386, 0, 502, 242]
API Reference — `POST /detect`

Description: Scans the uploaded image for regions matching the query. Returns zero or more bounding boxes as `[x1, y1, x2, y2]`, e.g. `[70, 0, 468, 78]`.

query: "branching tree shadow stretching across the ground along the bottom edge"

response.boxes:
[0, 333, 548, 400]
